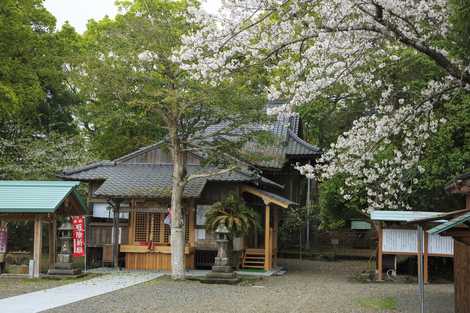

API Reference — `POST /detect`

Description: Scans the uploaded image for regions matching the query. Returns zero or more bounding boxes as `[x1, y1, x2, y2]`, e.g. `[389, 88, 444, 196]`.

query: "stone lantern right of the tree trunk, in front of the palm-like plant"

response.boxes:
[205, 224, 240, 284]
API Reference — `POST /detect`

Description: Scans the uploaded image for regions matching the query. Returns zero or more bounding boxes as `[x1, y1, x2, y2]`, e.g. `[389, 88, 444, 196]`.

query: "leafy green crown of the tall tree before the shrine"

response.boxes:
[72, 0, 265, 160]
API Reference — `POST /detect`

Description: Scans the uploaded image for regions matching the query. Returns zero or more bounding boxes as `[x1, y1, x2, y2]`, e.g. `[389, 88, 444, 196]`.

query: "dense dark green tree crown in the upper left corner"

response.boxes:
[0, 0, 78, 131]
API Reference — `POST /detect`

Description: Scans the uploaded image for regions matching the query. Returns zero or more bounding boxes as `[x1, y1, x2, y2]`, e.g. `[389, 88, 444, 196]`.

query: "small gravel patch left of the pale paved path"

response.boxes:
[0, 274, 98, 299]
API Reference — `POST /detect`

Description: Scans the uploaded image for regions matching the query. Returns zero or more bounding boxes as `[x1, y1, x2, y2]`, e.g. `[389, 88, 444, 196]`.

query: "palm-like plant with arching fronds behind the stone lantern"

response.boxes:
[206, 194, 259, 237]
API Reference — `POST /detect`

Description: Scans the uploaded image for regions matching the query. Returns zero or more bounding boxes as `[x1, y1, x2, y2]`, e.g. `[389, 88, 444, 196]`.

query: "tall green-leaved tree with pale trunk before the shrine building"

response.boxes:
[73, 0, 270, 279]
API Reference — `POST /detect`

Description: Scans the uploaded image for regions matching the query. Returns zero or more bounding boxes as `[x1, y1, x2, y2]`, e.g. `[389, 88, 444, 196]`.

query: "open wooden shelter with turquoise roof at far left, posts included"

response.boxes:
[0, 180, 87, 277]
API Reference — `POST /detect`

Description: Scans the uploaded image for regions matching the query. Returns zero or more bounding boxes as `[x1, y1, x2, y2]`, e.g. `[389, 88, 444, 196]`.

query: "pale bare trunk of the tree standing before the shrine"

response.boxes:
[170, 127, 186, 279]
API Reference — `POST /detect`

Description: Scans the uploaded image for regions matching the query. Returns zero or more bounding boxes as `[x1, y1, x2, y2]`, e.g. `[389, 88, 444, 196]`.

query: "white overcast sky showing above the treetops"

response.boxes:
[44, 0, 221, 33]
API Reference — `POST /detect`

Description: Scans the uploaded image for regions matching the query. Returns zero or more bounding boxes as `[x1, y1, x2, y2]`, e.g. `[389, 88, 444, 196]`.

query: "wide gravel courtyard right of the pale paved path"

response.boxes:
[43, 260, 453, 313]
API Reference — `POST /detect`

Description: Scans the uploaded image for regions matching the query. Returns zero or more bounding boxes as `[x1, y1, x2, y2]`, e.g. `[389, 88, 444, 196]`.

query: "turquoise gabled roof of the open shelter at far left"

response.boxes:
[0, 180, 87, 213]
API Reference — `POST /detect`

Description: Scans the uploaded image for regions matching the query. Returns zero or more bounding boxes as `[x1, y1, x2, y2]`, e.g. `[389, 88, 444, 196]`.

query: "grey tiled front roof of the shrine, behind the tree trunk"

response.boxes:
[61, 162, 259, 198]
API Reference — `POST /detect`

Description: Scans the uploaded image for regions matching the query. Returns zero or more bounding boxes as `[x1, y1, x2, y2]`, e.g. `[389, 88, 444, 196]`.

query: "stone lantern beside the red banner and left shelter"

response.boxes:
[47, 219, 81, 276]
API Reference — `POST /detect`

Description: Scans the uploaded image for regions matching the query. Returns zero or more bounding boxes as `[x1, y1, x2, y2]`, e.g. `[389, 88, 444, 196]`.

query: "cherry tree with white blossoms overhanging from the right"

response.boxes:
[174, 0, 470, 211]
